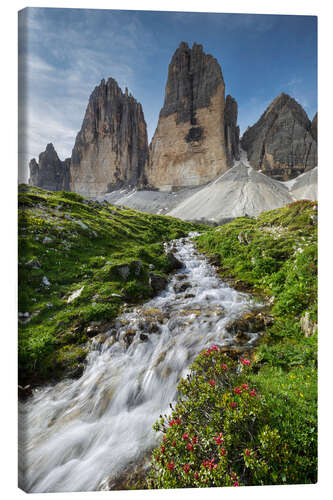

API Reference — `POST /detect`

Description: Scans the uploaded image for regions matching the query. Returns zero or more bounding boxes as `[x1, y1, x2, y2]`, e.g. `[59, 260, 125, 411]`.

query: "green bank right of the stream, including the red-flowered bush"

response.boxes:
[147, 201, 317, 488]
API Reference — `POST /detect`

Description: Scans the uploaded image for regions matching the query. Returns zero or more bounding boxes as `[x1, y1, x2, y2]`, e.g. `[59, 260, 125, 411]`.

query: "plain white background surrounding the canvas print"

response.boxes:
[0, 0, 333, 500]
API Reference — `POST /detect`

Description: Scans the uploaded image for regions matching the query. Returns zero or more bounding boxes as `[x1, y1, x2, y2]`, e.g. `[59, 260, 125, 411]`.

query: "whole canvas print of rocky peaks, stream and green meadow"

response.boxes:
[18, 8, 318, 492]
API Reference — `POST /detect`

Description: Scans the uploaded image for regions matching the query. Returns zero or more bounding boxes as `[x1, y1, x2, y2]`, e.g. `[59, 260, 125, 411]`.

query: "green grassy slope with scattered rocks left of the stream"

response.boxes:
[19, 185, 205, 384]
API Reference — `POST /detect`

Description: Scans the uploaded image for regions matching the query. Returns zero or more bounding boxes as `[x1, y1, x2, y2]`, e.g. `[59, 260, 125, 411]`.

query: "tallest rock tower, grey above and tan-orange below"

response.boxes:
[146, 42, 233, 191]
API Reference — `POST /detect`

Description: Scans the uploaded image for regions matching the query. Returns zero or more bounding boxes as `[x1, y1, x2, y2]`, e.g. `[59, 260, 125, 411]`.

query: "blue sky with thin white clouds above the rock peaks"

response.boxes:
[19, 8, 317, 179]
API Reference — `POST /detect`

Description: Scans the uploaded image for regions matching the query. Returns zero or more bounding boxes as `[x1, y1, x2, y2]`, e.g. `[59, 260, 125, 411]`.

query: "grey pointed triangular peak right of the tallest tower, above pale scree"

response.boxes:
[241, 94, 317, 180]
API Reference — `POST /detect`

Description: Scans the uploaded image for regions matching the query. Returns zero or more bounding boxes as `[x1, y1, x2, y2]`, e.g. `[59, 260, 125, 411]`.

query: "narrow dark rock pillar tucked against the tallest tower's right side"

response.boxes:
[224, 95, 239, 166]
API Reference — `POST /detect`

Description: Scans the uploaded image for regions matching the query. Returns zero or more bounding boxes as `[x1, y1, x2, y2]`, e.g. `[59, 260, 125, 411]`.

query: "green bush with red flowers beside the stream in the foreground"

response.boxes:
[147, 346, 290, 488]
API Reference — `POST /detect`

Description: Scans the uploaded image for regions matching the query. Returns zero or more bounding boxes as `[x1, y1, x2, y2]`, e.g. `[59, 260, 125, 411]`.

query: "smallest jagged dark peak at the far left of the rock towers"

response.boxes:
[29, 143, 70, 191]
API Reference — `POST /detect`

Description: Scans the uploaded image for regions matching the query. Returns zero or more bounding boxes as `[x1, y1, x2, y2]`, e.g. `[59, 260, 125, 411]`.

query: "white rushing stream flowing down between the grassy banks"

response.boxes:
[20, 238, 256, 492]
